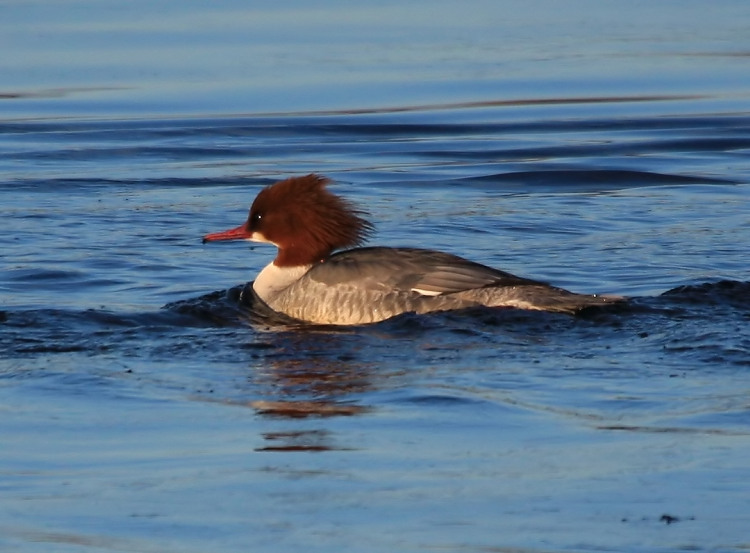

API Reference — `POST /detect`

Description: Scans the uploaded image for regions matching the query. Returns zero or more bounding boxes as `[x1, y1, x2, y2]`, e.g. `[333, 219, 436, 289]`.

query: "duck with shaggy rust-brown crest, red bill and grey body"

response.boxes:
[203, 174, 622, 325]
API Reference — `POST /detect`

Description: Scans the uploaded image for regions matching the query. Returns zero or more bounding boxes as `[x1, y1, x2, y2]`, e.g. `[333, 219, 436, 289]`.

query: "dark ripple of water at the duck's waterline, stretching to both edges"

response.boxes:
[0, 280, 750, 338]
